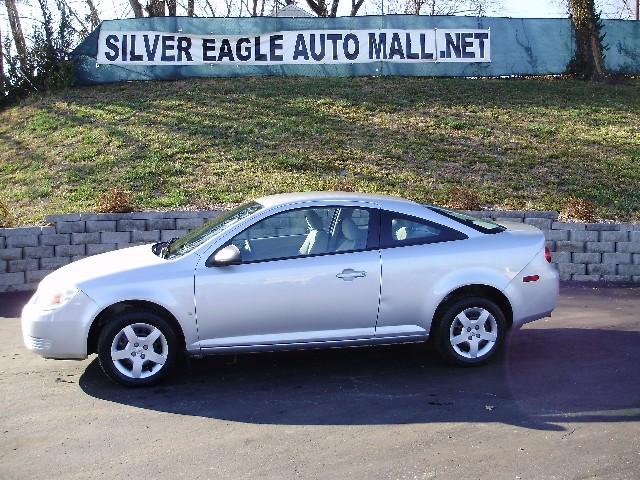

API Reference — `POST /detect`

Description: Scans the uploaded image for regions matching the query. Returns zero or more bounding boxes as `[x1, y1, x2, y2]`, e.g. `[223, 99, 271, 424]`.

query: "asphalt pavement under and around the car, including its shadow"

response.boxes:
[0, 287, 640, 479]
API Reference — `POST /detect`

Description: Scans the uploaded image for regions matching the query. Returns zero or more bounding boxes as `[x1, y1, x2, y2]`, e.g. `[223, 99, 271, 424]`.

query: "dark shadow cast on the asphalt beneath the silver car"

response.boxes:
[80, 328, 640, 430]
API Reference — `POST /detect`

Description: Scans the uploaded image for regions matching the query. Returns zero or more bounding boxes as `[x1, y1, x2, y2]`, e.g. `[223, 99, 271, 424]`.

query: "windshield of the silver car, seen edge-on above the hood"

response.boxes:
[164, 202, 262, 258]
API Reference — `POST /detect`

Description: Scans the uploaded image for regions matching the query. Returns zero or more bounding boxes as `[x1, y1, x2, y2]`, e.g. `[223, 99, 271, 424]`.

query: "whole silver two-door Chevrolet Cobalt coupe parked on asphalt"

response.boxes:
[22, 192, 558, 386]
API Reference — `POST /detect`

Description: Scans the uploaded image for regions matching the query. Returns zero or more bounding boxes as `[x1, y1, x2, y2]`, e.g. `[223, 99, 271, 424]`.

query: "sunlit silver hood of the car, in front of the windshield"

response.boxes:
[38, 245, 167, 288]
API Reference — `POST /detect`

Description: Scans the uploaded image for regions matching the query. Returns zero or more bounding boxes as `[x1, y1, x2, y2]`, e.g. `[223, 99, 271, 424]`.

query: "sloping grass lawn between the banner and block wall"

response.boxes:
[0, 77, 640, 224]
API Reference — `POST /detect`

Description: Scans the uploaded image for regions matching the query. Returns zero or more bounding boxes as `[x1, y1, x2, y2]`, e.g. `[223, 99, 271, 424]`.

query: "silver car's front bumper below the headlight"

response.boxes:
[21, 291, 98, 360]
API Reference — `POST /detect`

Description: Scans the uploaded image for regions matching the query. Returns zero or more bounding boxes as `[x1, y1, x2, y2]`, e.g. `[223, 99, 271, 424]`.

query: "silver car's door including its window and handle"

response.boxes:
[190, 206, 380, 349]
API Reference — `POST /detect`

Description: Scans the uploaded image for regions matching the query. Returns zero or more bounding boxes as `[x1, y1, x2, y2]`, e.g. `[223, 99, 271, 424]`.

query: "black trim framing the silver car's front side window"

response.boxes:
[205, 205, 381, 267]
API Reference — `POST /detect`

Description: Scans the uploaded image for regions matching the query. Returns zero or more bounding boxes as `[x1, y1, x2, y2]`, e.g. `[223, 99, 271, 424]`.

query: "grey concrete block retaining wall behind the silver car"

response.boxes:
[0, 210, 640, 292]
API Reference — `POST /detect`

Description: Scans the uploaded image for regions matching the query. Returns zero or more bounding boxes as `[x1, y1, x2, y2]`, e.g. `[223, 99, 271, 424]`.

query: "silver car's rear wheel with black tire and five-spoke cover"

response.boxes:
[434, 297, 507, 367]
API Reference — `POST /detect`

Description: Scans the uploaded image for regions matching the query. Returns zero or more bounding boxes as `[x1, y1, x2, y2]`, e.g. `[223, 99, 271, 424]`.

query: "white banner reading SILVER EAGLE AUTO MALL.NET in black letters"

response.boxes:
[97, 28, 491, 65]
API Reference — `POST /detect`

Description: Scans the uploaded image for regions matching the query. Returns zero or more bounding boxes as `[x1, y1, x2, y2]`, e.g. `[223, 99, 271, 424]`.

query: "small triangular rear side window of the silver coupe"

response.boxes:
[382, 212, 467, 247]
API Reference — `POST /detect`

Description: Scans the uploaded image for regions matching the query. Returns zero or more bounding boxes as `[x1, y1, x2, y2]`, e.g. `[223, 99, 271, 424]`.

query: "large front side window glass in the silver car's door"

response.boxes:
[231, 207, 370, 263]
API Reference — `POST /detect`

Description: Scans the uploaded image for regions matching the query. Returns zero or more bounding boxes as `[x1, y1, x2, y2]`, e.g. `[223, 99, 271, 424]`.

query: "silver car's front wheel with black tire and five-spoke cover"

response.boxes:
[98, 310, 181, 387]
